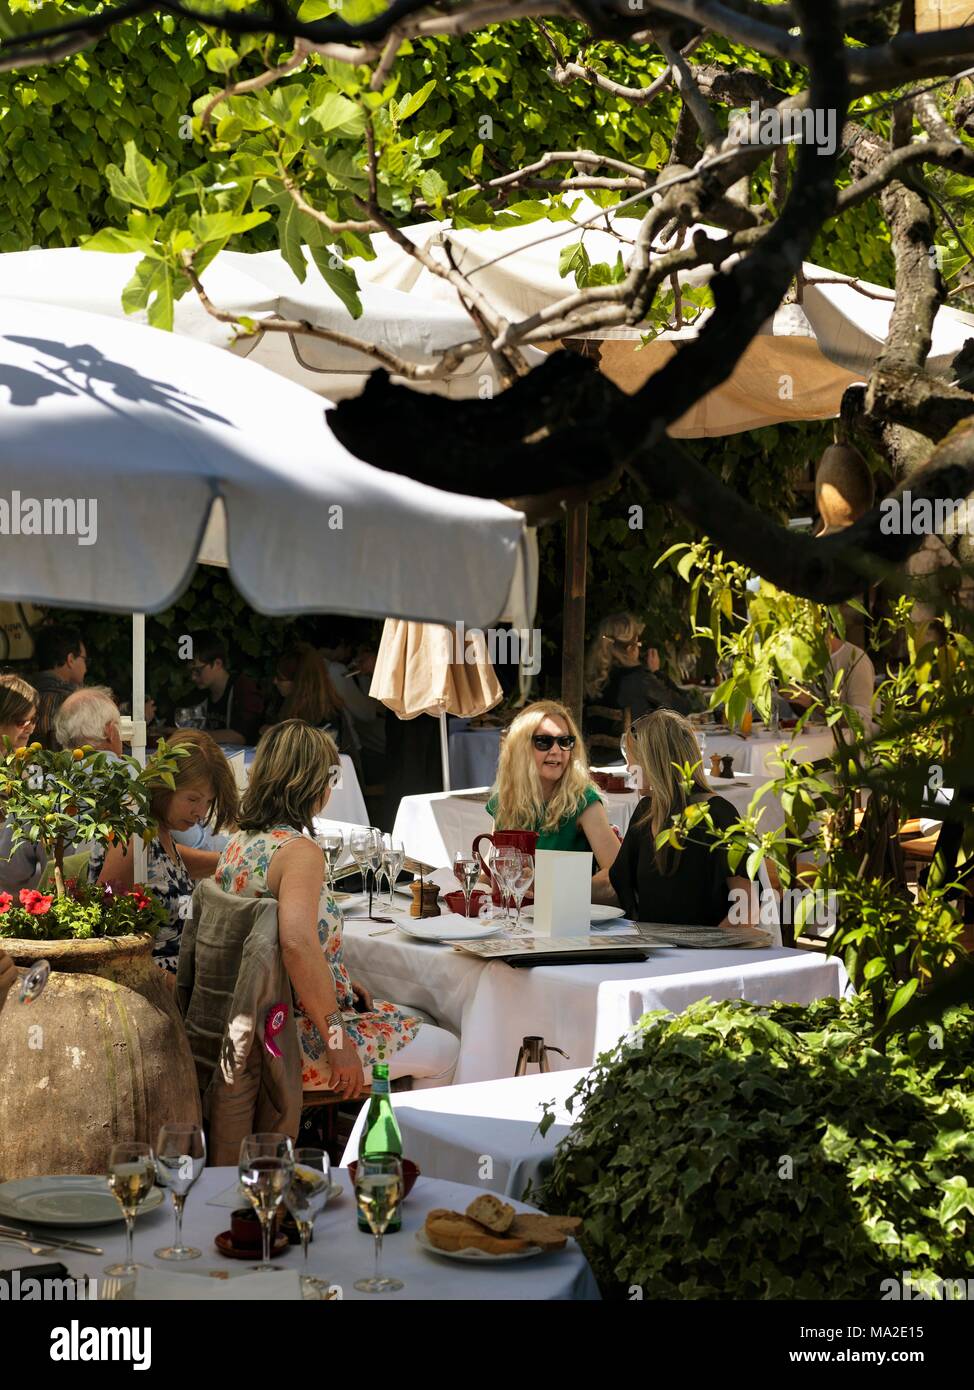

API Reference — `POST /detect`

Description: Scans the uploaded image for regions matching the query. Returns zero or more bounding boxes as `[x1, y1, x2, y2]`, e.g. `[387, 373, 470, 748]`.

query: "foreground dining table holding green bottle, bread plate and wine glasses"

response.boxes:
[0, 1168, 599, 1307]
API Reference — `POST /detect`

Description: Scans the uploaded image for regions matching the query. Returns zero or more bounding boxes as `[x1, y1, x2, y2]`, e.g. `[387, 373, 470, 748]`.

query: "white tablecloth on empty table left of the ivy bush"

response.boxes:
[342, 1068, 586, 1198]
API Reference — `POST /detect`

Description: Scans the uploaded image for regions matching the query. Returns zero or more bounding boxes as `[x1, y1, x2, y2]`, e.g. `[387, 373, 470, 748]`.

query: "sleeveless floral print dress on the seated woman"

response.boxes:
[215, 826, 422, 1090]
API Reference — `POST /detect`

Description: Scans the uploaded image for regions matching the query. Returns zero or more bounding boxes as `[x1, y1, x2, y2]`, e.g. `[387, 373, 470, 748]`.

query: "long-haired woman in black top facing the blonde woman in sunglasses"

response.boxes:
[592, 709, 760, 927]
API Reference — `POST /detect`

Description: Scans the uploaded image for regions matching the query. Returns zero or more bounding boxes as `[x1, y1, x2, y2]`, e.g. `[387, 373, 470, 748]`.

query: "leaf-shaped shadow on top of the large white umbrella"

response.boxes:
[0, 334, 232, 425]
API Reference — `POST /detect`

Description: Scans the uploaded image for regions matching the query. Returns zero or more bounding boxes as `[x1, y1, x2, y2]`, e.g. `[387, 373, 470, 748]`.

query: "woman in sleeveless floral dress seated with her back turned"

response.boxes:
[217, 719, 457, 1098]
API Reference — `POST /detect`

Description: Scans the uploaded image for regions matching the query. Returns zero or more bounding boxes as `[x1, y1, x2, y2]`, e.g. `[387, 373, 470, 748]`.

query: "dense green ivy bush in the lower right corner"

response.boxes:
[542, 999, 974, 1300]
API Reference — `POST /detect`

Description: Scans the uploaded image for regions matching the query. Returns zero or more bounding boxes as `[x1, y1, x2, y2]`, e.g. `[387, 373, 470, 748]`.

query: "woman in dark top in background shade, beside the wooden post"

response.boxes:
[584, 613, 691, 763]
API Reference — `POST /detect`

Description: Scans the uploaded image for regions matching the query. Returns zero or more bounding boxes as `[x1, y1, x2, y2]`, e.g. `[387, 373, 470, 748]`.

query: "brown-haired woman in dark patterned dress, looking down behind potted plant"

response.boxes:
[88, 728, 238, 976]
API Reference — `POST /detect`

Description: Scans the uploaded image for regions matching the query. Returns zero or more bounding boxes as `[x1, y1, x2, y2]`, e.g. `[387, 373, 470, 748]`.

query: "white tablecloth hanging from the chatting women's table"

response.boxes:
[345, 922, 848, 1084]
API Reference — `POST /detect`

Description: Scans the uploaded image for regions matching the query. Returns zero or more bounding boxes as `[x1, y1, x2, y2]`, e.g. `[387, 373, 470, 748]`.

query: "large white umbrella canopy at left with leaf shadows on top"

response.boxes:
[0, 299, 527, 626]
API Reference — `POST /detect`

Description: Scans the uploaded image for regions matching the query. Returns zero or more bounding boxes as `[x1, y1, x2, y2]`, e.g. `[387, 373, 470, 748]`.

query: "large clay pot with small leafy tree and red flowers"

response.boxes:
[0, 744, 200, 1179]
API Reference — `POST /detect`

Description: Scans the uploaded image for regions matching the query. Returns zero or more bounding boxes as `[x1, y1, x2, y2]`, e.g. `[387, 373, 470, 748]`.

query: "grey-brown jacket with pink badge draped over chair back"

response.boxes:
[176, 878, 302, 1165]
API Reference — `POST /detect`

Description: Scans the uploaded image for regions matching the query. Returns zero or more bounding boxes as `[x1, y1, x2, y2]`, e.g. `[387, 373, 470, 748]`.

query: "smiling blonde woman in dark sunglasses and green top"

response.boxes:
[486, 701, 620, 870]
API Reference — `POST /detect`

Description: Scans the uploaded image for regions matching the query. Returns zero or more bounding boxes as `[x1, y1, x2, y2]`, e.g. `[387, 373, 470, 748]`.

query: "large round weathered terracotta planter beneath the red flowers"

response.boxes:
[0, 935, 200, 1180]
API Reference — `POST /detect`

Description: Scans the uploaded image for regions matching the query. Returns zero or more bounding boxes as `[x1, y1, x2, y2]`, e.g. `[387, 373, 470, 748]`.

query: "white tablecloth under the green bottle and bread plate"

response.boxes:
[0, 1168, 599, 1308]
